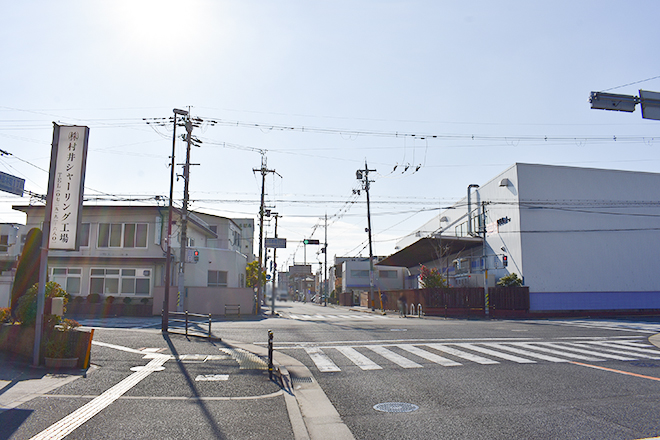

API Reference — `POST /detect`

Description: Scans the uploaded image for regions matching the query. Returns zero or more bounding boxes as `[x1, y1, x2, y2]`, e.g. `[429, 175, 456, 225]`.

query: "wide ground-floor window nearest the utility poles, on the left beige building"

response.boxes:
[89, 268, 151, 296]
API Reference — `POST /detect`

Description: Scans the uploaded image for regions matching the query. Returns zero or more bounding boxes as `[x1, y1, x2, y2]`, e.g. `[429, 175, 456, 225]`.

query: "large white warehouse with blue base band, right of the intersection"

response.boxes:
[379, 164, 660, 312]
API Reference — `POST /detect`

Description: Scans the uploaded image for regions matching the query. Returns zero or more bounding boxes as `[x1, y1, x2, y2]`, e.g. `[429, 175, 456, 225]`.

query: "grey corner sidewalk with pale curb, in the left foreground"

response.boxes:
[0, 330, 353, 440]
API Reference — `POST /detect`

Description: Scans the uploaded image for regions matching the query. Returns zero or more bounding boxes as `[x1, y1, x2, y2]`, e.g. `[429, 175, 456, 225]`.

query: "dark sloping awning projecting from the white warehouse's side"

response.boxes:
[377, 236, 483, 268]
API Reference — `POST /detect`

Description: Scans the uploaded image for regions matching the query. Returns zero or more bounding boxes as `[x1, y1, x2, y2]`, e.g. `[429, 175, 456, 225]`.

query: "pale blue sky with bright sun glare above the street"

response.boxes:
[0, 0, 660, 271]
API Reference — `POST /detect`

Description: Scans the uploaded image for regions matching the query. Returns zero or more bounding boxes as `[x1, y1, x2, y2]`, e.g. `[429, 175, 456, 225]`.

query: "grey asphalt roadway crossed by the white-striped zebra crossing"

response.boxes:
[241, 303, 660, 439]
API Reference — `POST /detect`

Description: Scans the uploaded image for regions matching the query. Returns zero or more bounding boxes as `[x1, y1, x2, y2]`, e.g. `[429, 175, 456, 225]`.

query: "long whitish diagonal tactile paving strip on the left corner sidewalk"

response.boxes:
[30, 356, 169, 440]
